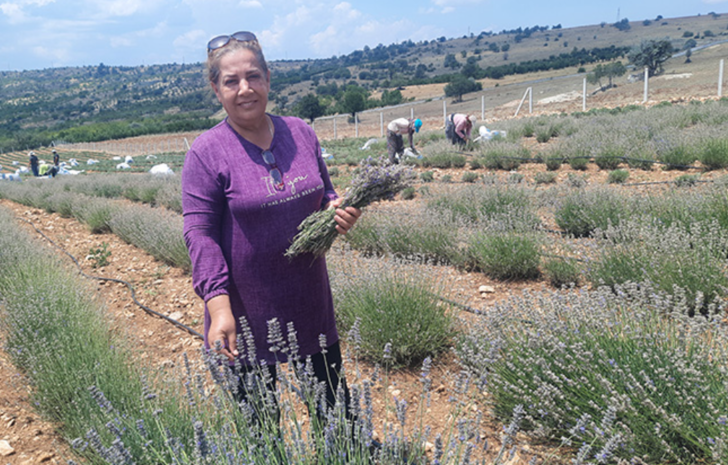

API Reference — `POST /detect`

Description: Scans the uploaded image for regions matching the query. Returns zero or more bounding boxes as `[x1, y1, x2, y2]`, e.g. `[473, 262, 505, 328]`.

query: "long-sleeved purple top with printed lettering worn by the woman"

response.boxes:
[182, 115, 339, 362]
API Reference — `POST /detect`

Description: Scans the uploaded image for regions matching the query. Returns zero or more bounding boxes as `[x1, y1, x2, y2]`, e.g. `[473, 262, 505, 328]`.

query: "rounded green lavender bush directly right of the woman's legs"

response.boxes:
[332, 260, 454, 367]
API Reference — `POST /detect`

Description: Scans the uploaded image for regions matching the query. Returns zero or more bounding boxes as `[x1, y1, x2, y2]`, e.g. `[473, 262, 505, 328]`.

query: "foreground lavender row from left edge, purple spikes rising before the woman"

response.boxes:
[0, 206, 494, 465]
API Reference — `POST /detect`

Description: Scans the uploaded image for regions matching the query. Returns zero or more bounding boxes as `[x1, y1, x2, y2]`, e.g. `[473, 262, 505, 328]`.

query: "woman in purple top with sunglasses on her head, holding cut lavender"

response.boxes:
[182, 32, 361, 416]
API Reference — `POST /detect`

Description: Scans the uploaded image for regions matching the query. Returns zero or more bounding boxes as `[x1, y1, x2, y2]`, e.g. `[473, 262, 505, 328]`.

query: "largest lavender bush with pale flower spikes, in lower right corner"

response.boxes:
[457, 285, 728, 463]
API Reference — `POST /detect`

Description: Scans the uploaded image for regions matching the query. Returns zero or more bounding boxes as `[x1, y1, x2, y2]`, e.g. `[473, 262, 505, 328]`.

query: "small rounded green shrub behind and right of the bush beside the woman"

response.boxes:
[467, 232, 541, 280]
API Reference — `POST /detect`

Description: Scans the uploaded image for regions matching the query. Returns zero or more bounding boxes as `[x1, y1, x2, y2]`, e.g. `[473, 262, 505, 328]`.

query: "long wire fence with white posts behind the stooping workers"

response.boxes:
[312, 59, 724, 139]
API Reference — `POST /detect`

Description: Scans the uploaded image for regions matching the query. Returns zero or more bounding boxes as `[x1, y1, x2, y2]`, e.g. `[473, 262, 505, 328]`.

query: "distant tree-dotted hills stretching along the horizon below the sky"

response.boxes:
[0, 13, 728, 152]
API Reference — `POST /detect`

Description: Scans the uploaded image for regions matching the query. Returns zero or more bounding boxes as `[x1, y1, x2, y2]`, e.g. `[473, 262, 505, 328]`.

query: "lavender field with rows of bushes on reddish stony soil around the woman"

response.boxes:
[0, 100, 728, 464]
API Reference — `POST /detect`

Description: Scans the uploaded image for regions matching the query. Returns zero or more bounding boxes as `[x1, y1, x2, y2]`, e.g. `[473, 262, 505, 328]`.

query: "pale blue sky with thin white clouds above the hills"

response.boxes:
[0, 0, 728, 70]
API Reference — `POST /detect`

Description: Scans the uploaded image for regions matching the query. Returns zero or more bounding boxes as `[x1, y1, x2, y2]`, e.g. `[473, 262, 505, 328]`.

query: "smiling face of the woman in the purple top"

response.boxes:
[212, 49, 270, 129]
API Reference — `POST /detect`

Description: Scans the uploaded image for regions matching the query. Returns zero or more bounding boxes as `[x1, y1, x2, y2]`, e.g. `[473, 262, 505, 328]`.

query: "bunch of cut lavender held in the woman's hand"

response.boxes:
[285, 157, 415, 258]
